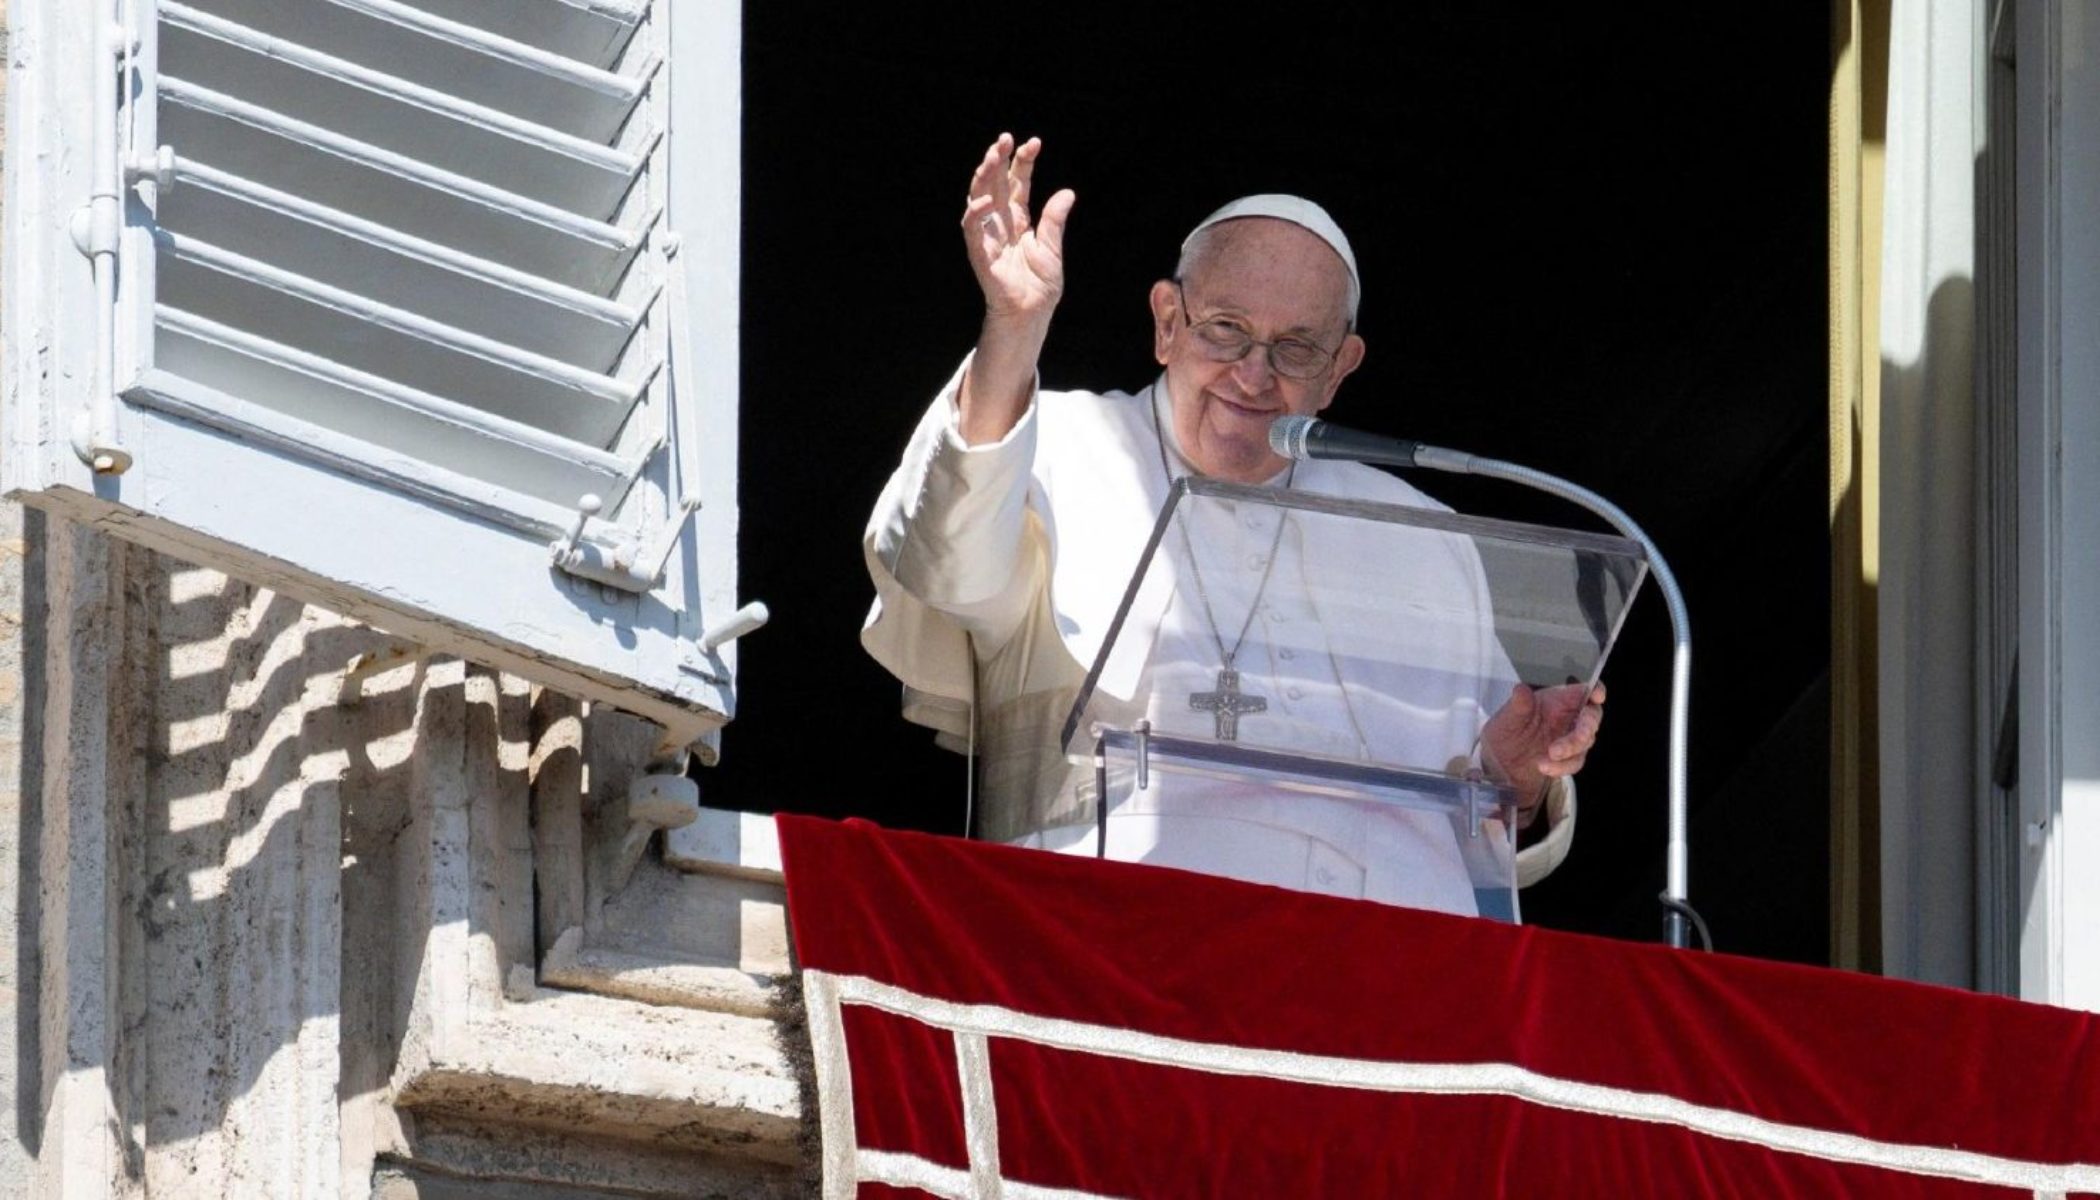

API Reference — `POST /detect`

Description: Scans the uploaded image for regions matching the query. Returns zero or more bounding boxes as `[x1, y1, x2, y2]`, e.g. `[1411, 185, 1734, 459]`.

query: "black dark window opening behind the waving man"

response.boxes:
[704, 0, 1829, 963]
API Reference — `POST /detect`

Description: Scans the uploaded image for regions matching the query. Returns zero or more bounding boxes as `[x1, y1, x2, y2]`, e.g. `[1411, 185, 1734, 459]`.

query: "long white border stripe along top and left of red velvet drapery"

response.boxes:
[804, 971, 2100, 1196]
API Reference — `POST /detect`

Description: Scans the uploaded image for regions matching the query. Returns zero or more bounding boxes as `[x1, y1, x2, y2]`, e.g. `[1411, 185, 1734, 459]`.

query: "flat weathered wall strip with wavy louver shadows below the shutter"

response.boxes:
[139, 549, 371, 1196]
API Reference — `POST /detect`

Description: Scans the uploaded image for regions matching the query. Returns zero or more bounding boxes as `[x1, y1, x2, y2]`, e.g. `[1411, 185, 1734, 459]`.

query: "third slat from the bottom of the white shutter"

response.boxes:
[160, 160, 643, 372]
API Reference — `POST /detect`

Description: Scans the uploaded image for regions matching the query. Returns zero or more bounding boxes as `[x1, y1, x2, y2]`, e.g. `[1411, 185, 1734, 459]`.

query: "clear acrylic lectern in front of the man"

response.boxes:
[979, 479, 1646, 920]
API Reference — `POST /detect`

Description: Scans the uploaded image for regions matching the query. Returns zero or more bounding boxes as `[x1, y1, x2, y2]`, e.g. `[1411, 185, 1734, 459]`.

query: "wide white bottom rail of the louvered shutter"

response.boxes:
[18, 410, 731, 738]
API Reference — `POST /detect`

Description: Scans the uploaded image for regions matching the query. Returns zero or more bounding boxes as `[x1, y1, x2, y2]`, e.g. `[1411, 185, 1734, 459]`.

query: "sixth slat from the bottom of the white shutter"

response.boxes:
[187, 0, 647, 145]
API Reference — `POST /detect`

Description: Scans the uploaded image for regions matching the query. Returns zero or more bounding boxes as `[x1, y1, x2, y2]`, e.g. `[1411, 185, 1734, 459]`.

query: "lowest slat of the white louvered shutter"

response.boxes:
[155, 307, 634, 506]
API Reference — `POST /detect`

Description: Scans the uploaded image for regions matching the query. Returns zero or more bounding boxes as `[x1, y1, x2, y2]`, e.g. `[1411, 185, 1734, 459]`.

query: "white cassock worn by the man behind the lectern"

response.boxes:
[861, 361, 1575, 912]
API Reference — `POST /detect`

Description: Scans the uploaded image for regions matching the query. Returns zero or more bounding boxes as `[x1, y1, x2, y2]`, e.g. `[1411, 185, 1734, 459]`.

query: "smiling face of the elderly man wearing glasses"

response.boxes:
[1151, 216, 1363, 483]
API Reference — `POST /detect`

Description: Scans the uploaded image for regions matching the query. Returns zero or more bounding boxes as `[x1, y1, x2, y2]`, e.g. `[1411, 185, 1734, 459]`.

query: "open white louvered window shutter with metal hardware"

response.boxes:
[4, 0, 739, 752]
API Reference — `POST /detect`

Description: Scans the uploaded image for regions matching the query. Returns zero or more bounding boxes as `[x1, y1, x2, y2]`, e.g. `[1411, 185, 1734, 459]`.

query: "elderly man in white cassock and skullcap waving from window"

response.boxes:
[863, 135, 1602, 912]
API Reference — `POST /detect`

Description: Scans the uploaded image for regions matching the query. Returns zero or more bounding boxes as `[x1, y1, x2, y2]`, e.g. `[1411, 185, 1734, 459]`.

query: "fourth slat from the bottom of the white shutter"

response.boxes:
[160, 78, 641, 294]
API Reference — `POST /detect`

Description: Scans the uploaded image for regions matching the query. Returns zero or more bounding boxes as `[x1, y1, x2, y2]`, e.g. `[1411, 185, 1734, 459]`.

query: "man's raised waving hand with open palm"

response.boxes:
[962, 132, 1075, 326]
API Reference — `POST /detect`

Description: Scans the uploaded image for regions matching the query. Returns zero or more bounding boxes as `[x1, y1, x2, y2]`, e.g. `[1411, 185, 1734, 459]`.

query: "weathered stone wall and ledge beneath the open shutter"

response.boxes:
[0, 521, 800, 1198]
